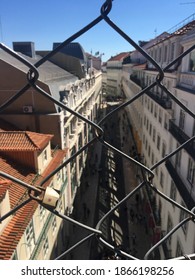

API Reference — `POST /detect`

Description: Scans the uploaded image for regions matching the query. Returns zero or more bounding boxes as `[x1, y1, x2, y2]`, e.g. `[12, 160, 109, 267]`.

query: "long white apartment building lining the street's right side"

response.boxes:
[106, 16, 195, 259]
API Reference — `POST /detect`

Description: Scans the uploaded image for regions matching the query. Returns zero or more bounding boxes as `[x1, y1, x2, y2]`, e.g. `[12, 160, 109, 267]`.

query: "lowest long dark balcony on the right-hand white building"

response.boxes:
[165, 160, 194, 209]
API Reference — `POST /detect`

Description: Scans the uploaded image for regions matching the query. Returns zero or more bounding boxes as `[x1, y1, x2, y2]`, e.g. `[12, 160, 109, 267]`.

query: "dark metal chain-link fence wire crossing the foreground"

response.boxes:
[0, 0, 195, 260]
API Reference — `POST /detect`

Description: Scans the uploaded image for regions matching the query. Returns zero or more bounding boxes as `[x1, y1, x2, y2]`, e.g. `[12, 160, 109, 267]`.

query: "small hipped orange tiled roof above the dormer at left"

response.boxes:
[0, 131, 53, 151]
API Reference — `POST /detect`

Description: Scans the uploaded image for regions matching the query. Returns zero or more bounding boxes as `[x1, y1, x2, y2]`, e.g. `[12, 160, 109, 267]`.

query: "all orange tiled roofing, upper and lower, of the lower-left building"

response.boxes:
[0, 121, 67, 260]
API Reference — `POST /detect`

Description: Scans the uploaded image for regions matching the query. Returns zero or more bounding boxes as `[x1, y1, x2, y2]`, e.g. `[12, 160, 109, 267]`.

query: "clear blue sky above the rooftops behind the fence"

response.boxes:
[0, 0, 195, 61]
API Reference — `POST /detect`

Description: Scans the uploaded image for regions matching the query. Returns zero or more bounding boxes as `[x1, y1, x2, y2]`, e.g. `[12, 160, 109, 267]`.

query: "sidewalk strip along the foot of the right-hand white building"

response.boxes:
[120, 109, 151, 259]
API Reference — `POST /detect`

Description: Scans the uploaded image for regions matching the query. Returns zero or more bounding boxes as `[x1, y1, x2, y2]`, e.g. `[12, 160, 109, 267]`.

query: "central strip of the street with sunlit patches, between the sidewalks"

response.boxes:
[93, 106, 129, 259]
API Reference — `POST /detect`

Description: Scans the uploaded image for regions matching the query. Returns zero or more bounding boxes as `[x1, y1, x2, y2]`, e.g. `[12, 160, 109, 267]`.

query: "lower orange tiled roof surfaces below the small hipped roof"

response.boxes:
[0, 150, 66, 260]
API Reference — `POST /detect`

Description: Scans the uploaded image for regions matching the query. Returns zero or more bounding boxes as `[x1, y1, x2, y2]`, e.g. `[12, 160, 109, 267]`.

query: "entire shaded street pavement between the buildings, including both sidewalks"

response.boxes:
[67, 103, 151, 260]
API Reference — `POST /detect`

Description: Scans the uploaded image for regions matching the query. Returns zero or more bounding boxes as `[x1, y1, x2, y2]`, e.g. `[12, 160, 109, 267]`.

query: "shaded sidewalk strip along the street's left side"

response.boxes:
[66, 139, 102, 260]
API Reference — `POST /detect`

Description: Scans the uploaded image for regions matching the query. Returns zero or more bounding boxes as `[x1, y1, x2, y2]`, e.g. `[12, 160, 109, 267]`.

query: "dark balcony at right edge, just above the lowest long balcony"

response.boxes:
[169, 120, 195, 160]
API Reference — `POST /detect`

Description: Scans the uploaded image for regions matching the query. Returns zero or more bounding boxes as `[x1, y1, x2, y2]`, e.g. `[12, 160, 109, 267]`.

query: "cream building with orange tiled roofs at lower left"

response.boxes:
[0, 121, 67, 260]
